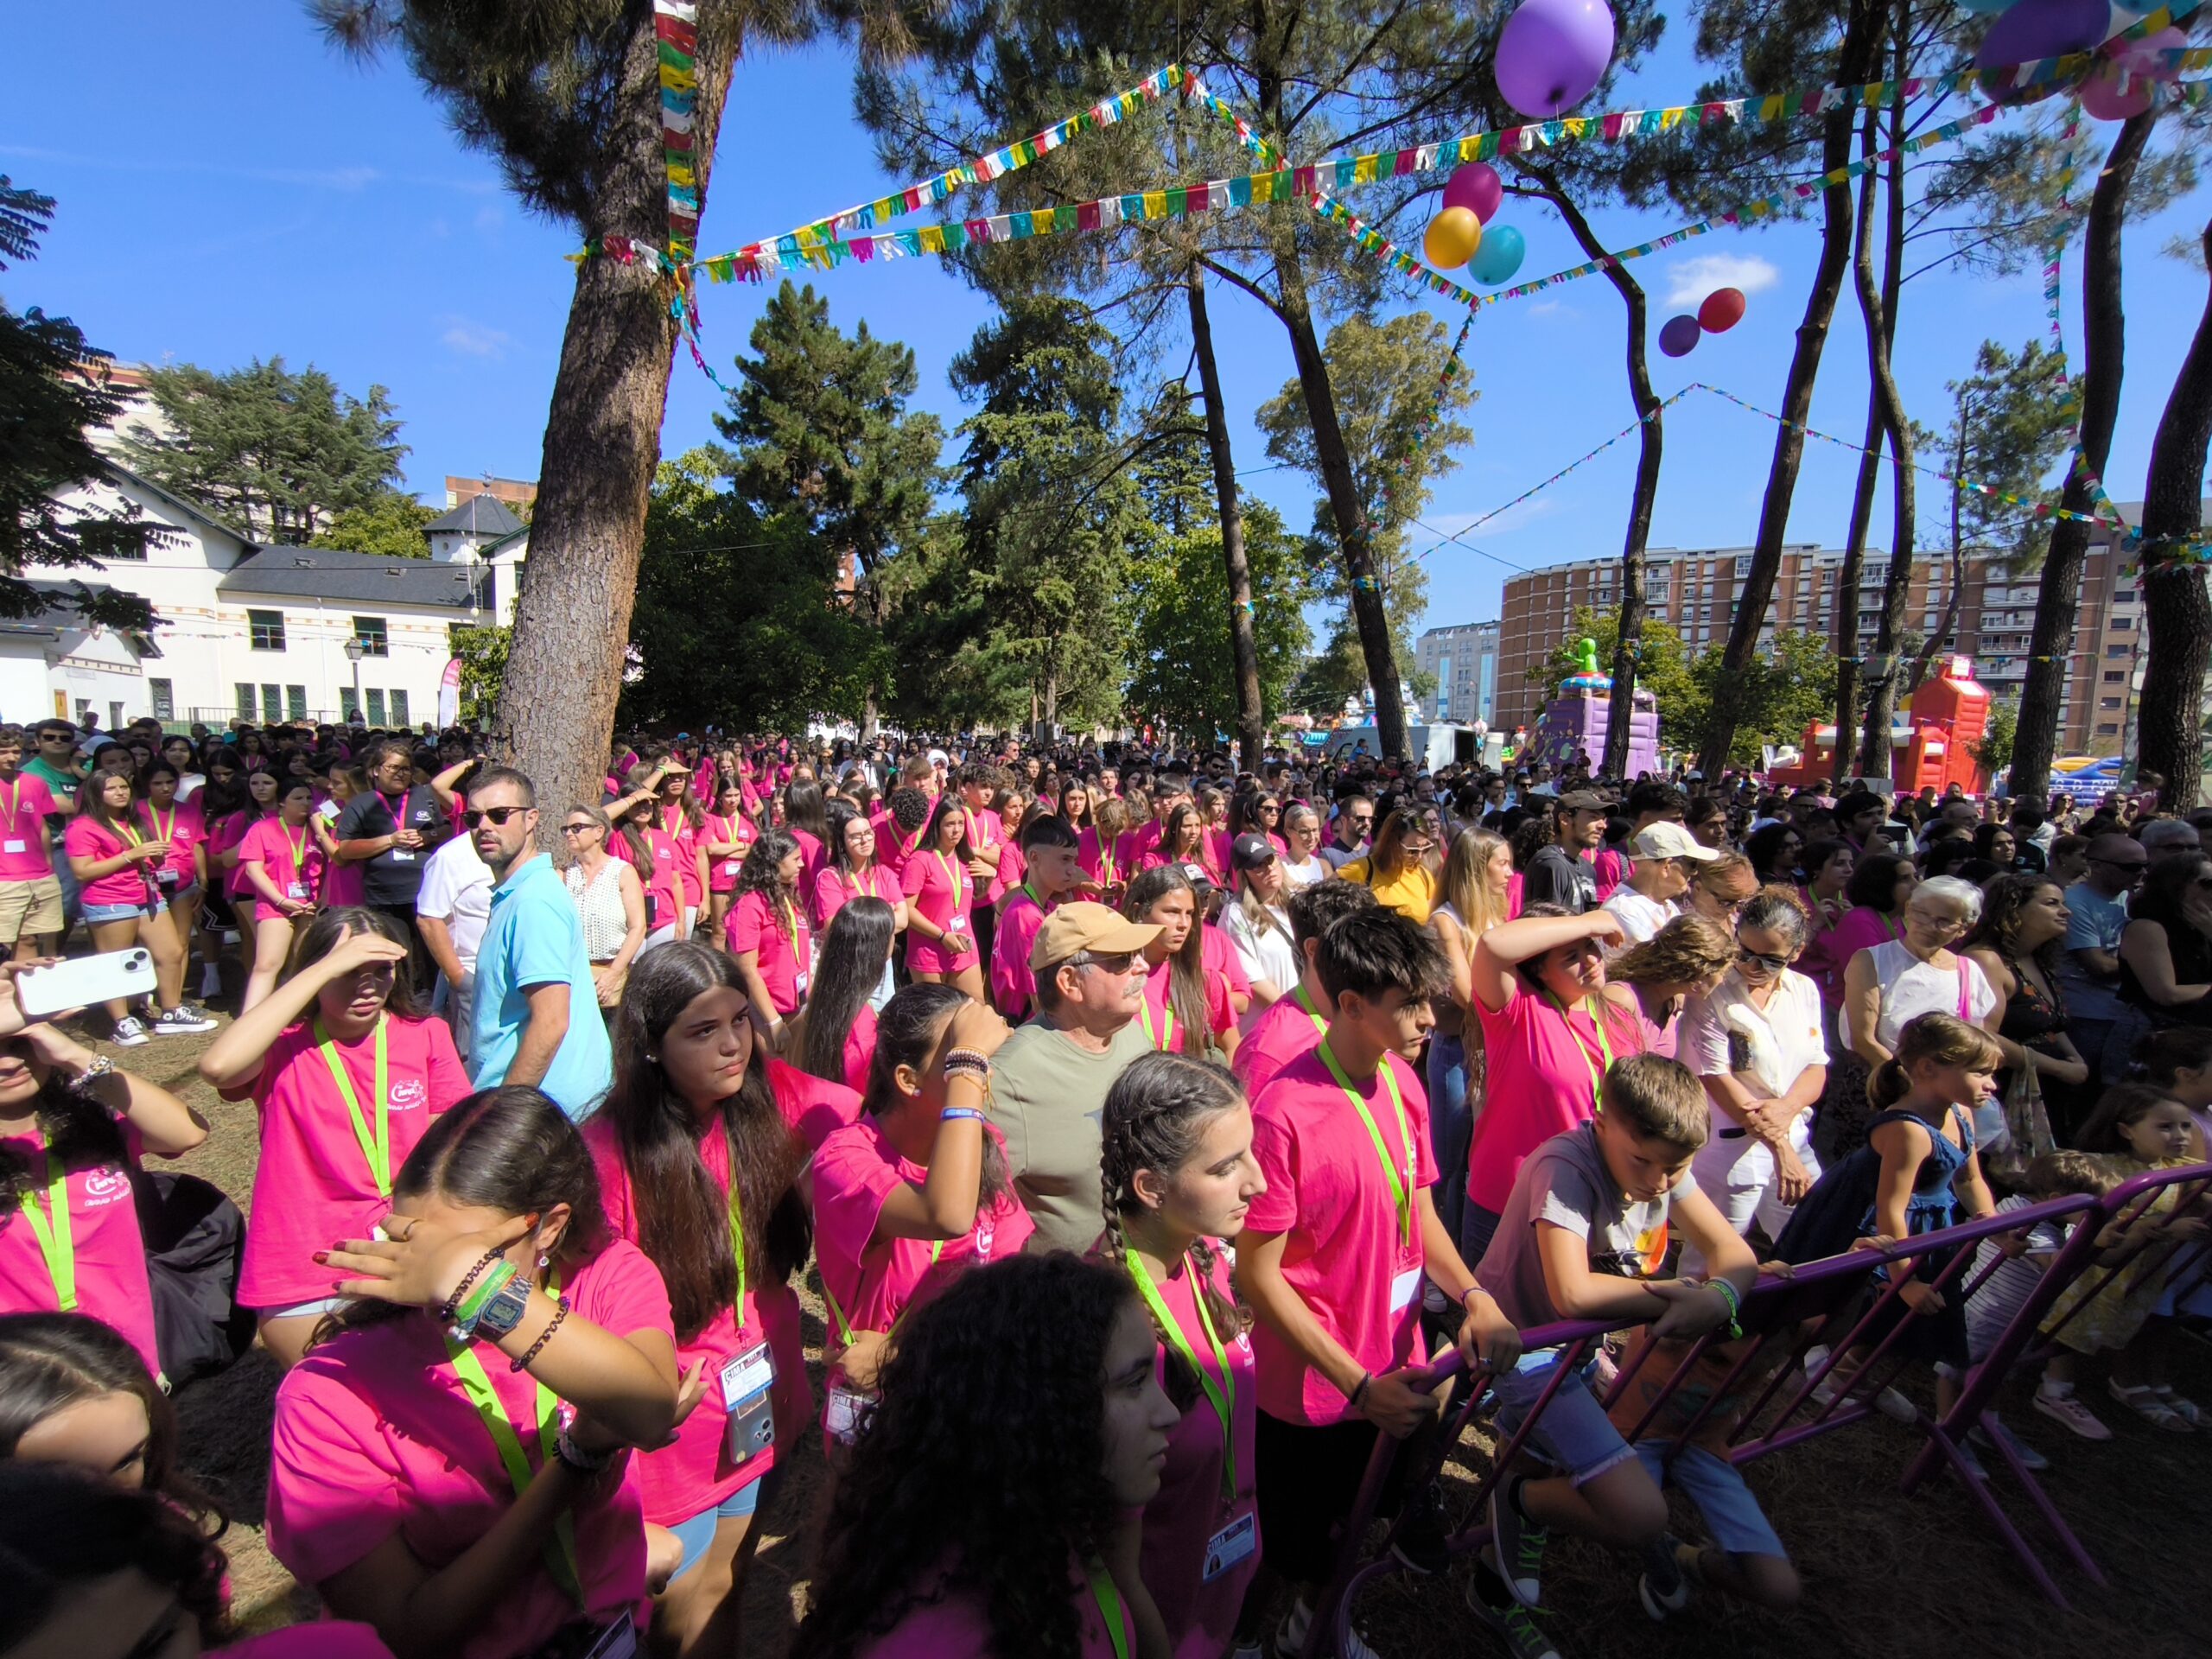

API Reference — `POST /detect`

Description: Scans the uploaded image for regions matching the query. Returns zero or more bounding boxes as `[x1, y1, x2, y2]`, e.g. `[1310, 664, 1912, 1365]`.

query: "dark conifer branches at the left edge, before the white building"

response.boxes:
[0, 175, 163, 628]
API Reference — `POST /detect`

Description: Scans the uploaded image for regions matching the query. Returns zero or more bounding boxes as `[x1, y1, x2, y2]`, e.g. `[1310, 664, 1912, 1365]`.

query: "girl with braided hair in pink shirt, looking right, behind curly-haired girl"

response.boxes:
[1095, 1053, 1268, 1656]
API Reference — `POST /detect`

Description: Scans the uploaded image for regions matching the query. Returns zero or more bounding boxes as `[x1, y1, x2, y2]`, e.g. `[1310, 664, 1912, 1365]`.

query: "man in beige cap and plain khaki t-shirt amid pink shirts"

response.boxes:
[991, 902, 1159, 1252]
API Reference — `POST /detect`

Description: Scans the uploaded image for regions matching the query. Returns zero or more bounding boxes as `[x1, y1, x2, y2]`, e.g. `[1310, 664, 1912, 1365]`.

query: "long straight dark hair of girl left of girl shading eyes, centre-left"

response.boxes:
[601, 940, 814, 1343]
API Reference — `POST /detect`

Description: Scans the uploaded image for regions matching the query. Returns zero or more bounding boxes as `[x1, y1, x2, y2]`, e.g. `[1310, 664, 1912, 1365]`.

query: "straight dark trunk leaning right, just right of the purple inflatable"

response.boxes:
[1697, 0, 1889, 779]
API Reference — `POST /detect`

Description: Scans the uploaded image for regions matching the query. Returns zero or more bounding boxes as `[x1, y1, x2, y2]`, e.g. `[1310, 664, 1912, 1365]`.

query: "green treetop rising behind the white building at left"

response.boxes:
[124, 356, 407, 542]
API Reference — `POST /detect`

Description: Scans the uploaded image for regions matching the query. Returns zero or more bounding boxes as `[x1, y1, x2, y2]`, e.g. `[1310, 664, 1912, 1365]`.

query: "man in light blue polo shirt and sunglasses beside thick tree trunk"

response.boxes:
[462, 766, 615, 1119]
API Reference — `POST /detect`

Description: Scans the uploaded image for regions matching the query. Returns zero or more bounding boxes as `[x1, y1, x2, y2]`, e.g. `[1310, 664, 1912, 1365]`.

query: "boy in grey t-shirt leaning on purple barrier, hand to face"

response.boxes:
[1466, 1055, 1758, 1643]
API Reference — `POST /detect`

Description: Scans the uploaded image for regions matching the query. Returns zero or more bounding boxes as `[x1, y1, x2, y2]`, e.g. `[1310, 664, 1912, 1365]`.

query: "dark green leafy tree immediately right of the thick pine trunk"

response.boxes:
[617, 449, 885, 732]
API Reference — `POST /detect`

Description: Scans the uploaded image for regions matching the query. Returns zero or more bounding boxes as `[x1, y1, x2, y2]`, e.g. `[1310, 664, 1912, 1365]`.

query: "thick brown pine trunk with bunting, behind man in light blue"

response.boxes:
[493, 22, 734, 849]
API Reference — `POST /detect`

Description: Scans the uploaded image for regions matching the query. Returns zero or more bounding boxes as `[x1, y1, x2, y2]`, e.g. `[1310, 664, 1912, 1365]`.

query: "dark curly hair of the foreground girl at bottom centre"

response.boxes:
[791, 1252, 1137, 1659]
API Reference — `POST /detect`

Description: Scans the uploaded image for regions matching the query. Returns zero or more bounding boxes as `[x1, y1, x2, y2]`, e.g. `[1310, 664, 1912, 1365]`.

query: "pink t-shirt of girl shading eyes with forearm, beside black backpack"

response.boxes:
[232, 1015, 469, 1310]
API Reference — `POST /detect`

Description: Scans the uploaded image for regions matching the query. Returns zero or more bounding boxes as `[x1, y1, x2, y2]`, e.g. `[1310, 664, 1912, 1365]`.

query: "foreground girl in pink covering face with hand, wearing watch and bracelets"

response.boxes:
[268, 1086, 677, 1659]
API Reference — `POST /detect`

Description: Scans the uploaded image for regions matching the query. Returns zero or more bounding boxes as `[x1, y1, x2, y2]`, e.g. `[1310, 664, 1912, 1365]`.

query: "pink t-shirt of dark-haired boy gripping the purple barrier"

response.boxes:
[1245, 1051, 1435, 1422]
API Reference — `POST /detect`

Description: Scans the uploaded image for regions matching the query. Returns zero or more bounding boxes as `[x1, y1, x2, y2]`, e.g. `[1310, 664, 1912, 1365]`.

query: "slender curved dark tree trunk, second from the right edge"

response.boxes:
[2013, 108, 2159, 794]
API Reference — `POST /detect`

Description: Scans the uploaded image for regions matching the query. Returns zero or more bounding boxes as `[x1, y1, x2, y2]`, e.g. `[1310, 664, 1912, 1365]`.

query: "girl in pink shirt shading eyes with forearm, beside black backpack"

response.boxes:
[199, 909, 469, 1365]
